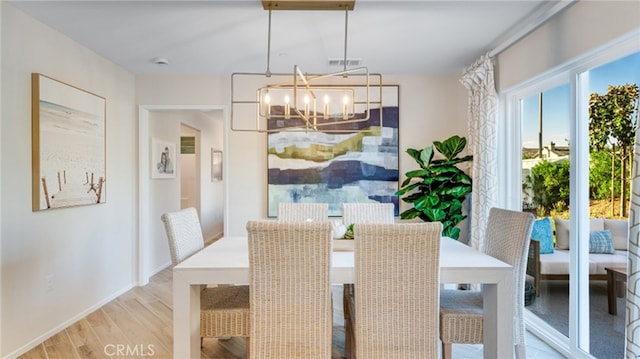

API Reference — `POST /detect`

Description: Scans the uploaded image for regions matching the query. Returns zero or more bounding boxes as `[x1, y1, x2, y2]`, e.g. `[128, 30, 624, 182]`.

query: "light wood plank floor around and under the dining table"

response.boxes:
[20, 268, 563, 359]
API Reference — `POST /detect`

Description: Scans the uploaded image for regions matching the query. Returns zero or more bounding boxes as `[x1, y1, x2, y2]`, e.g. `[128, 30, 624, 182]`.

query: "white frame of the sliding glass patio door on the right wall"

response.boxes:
[498, 32, 640, 358]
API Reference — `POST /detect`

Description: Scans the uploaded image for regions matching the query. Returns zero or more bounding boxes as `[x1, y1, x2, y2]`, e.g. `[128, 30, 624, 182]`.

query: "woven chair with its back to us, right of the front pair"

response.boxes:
[345, 222, 442, 359]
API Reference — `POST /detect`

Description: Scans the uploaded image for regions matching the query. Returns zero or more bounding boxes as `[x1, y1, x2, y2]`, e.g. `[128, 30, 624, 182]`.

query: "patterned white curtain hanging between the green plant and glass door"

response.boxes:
[460, 55, 498, 250]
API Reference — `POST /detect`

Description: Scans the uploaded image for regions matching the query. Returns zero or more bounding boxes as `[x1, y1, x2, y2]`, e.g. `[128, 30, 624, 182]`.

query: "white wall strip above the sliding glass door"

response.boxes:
[496, 1, 640, 91]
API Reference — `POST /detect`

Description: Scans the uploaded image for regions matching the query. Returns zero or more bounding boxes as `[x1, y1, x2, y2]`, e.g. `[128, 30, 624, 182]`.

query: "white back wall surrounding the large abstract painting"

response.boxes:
[136, 75, 467, 235]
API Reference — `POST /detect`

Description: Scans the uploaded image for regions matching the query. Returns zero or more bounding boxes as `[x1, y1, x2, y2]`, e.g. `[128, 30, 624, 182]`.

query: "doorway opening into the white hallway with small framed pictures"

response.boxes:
[135, 105, 228, 285]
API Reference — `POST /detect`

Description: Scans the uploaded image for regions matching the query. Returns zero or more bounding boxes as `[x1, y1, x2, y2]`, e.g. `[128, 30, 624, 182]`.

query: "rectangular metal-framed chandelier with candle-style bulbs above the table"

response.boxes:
[231, 0, 382, 133]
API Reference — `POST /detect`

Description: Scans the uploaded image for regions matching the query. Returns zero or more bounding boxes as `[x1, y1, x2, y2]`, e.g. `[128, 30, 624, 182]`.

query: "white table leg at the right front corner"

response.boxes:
[482, 271, 516, 358]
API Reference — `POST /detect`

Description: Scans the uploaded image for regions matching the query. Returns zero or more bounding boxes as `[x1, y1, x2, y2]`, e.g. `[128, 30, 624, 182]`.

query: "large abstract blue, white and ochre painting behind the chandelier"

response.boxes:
[268, 86, 399, 217]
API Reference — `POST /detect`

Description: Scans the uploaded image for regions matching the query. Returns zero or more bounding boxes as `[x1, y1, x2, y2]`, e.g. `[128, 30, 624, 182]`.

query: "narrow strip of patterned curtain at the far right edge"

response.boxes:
[626, 121, 640, 358]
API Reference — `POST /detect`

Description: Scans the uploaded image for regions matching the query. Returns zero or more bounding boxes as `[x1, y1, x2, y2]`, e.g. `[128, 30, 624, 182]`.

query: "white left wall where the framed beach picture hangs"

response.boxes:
[0, 1, 136, 357]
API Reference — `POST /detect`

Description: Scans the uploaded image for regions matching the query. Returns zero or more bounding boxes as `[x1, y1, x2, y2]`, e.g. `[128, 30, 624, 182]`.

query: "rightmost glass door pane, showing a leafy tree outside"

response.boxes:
[588, 53, 640, 358]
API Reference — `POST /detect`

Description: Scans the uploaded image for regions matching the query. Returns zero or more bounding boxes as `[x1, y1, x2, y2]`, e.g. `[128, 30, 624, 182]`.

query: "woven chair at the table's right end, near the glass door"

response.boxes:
[440, 208, 534, 359]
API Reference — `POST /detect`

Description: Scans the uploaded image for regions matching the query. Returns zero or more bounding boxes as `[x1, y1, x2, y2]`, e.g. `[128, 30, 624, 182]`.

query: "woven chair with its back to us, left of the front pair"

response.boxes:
[247, 221, 333, 359]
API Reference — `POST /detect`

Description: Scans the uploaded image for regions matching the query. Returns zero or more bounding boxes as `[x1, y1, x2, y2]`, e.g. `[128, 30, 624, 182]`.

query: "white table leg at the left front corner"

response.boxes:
[173, 272, 200, 358]
